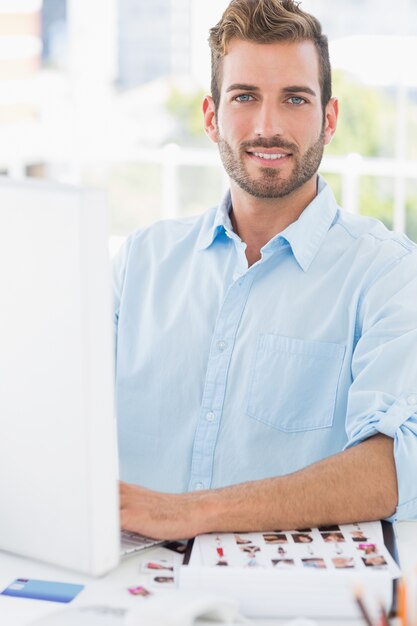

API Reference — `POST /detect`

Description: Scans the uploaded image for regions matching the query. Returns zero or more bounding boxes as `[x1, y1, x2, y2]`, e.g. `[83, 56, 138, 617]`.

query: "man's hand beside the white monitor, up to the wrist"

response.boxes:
[120, 482, 205, 539]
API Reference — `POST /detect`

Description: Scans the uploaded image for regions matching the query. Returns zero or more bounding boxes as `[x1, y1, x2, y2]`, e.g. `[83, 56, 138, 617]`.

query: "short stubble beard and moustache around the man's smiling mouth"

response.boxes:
[218, 128, 324, 199]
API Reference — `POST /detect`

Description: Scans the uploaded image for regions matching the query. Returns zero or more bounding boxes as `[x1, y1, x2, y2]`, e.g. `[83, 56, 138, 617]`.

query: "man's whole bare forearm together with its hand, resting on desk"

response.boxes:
[120, 435, 398, 539]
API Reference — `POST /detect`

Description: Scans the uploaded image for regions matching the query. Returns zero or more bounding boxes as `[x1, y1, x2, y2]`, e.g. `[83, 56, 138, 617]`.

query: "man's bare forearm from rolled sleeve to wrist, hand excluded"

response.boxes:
[195, 435, 398, 532]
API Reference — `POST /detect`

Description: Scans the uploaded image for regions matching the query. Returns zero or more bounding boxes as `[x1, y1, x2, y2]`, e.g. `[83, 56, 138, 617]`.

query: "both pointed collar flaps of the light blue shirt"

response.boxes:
[198, 176, 337, 272]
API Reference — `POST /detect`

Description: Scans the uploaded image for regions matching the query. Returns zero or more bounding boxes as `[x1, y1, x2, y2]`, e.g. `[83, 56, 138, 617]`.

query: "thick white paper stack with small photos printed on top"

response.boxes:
[179, 522, 401, 618]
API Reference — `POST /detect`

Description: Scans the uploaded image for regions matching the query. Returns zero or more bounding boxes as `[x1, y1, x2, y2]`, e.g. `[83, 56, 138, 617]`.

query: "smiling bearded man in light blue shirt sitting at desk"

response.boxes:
[115, 0, 417, 538]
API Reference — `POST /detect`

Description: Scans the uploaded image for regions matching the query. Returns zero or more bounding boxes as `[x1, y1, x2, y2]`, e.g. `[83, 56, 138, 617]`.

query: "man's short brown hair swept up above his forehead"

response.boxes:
[209, 0, 332, 111]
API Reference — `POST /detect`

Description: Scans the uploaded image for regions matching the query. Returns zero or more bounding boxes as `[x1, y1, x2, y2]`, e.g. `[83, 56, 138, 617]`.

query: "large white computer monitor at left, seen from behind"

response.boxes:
[0, 179, 120, 575]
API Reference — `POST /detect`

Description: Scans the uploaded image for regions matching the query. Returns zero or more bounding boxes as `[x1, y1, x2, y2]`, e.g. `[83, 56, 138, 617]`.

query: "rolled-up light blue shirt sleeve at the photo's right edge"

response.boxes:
[345, 249, 417, 521]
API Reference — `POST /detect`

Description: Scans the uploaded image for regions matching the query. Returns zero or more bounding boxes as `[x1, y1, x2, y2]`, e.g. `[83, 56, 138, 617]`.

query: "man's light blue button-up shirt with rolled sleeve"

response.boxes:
[114, 174, 417, 518]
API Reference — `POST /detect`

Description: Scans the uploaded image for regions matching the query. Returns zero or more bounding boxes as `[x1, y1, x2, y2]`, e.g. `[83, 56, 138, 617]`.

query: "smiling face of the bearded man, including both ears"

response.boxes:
[204, 39, 337, 198]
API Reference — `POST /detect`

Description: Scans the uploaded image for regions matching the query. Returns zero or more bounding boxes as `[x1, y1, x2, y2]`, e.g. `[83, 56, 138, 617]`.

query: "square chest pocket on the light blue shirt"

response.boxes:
[247, 334, 345, 432]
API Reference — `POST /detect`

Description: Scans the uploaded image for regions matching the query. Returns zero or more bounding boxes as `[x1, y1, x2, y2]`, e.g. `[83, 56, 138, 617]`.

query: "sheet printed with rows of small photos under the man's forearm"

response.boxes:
[189, 522, 400, 578]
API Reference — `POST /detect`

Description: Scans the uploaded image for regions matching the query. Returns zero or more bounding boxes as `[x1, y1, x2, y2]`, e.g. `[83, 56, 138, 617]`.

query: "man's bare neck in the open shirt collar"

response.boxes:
[230, 177, 317, 267]
